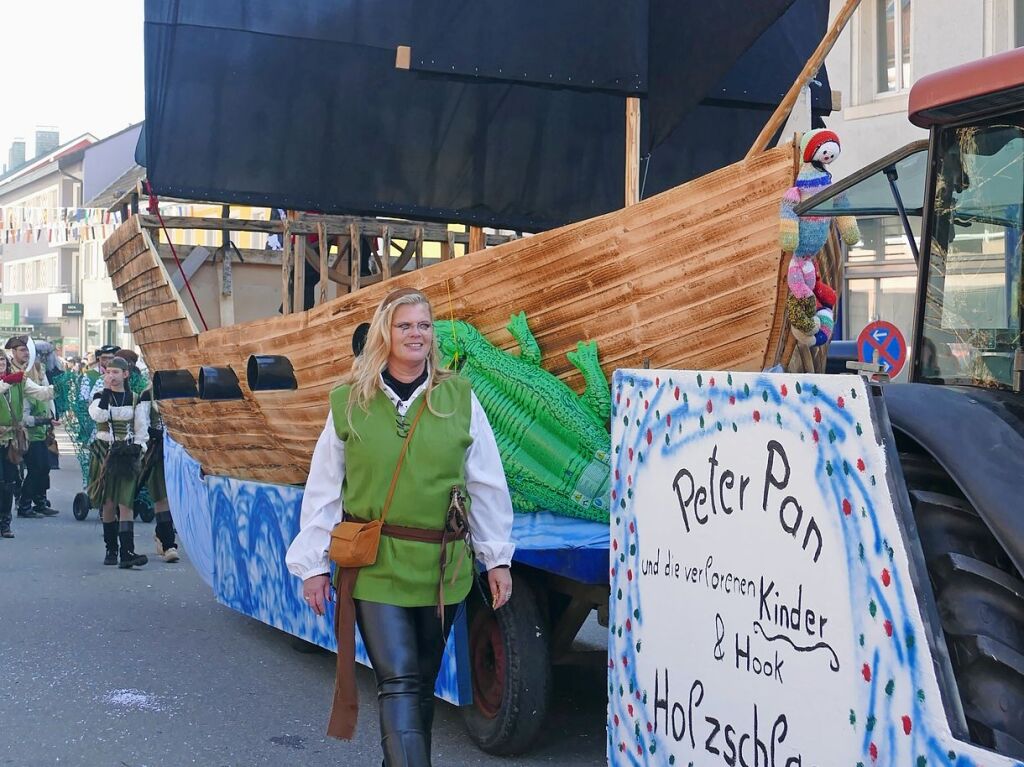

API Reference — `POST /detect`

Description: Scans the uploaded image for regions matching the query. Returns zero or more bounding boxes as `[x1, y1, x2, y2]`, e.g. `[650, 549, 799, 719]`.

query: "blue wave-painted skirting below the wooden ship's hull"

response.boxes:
[164, 434, 472, 706]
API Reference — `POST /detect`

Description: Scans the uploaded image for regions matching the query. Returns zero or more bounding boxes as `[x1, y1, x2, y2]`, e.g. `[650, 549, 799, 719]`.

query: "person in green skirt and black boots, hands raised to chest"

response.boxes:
[89, 357, 150, 569]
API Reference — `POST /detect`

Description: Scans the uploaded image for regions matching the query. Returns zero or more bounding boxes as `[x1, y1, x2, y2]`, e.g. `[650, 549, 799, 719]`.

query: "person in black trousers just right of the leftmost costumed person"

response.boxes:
[17, 343, 57, 517]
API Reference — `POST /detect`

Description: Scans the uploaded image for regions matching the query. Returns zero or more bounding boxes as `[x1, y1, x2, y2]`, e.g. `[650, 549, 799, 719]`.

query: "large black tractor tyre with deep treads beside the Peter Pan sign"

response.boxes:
[900, 453, 1024, 759]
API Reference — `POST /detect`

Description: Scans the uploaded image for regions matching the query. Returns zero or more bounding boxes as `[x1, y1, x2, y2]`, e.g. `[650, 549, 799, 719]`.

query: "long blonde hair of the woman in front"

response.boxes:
[341, 288, 454, 433]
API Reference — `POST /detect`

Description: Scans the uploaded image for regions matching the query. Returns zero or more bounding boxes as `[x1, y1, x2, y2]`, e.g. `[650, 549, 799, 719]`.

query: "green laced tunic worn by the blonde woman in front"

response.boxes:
[331, 377, 473, 607]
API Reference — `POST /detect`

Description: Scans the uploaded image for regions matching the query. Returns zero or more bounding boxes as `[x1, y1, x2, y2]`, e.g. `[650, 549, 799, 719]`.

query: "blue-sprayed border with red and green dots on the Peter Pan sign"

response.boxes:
[607, 371, 1024, 767]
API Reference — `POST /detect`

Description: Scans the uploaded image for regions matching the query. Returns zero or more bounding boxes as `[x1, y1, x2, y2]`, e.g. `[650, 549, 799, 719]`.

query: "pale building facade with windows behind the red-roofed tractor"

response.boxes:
[826, 0, 1024, 380]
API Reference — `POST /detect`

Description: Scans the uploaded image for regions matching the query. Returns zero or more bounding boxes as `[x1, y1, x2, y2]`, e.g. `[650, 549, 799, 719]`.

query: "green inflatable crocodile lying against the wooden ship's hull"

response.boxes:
[434, 312, 611, 522]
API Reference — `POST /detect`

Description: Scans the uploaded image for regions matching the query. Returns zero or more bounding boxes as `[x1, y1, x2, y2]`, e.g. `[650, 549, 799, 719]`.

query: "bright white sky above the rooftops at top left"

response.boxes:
[0, 0, 144, 164]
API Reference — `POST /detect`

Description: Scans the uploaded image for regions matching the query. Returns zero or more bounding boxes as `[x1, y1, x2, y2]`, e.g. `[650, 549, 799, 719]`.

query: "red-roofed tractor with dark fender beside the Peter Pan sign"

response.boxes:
[797, 49, 1024, 759]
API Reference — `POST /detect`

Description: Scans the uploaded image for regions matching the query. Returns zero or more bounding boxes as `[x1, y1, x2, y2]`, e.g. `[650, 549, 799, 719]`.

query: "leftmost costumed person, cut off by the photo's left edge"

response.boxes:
[0, 336, 53, 538]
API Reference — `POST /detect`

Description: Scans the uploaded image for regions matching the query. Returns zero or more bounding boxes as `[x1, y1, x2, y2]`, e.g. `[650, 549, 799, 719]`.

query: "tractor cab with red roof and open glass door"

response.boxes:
[797, 50, 1024, 392]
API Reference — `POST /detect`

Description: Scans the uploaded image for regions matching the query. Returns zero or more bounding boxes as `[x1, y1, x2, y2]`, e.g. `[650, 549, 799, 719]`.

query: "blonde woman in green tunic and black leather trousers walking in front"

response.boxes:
[286, 289, 514, 767]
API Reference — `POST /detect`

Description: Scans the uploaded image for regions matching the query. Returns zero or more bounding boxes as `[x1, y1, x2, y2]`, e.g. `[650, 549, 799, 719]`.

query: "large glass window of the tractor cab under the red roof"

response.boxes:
[918, 113, 1024, 388]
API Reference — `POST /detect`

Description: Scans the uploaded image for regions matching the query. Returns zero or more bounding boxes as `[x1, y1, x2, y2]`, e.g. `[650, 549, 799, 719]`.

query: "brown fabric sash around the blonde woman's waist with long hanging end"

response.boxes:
[327, 517, 466, 740]
